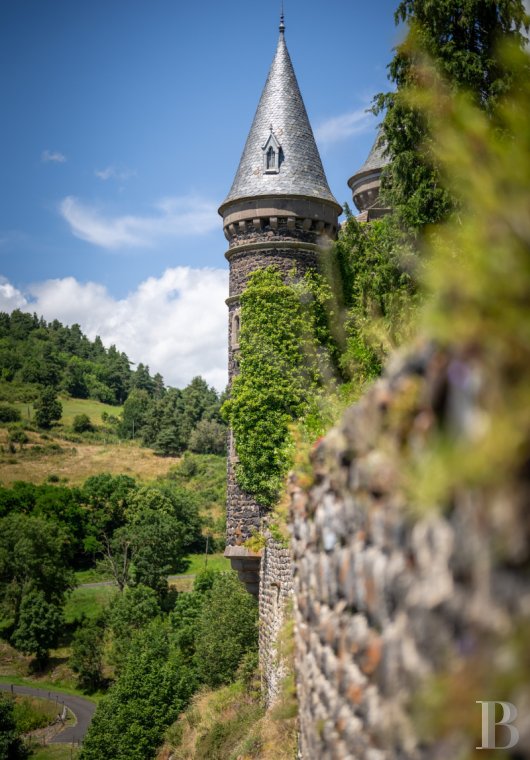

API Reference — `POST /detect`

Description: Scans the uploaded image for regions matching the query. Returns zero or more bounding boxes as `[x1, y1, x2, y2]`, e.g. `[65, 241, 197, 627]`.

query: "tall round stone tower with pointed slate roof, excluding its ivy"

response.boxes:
[219, 15, 341, 593]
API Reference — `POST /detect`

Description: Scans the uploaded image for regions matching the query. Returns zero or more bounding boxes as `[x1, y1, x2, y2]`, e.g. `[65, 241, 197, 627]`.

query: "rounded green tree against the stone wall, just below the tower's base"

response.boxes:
[195, 572, 258, 688]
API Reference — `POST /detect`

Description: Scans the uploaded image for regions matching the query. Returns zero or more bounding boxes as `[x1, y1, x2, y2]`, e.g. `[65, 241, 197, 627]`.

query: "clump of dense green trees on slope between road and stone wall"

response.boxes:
[81, 573, 257, 760]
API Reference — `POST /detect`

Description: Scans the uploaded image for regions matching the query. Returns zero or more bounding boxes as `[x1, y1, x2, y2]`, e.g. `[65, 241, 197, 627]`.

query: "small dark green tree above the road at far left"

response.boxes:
[11, 590, 63, 668]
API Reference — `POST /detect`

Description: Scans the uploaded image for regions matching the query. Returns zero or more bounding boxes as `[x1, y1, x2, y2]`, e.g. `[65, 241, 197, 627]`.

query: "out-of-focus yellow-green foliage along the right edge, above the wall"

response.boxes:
[414, 49, 530, 510]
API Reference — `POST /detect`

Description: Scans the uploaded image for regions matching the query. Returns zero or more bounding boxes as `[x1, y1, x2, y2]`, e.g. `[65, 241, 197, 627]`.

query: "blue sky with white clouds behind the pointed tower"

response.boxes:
[0, 0, 398, 387]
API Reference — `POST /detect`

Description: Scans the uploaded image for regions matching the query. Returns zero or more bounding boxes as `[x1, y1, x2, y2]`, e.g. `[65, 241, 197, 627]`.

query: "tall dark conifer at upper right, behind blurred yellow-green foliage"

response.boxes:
[374, 0, 529, 230]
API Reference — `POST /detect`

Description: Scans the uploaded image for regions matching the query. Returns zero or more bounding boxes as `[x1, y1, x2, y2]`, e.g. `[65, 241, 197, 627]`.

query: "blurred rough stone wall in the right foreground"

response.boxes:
[288, 347, 530, 760]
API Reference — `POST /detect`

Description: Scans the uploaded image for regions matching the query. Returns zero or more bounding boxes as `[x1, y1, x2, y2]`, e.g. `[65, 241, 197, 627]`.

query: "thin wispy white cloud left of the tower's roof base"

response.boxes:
[59, 196, 219, 249]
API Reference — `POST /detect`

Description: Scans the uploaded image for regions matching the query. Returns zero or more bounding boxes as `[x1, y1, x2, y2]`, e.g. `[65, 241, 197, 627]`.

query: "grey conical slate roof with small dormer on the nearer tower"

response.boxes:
[221, 22, 338, 209]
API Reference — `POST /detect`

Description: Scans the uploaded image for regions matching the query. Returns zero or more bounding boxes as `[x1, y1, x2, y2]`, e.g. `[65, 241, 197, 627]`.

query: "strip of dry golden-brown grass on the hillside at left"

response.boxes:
[0, 428, 180, 485]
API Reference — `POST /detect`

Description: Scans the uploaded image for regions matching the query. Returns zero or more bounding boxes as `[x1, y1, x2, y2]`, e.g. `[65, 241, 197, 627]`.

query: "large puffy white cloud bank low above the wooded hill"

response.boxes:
[0, 267, 228, 390]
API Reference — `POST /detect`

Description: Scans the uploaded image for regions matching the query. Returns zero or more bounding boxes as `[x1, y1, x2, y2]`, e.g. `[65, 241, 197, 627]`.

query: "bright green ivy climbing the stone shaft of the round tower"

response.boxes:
[223, 267, 333, 506]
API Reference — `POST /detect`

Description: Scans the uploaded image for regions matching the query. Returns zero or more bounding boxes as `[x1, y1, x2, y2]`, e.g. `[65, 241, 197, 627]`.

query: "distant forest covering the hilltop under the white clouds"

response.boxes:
[0, 309, 226, 455]
